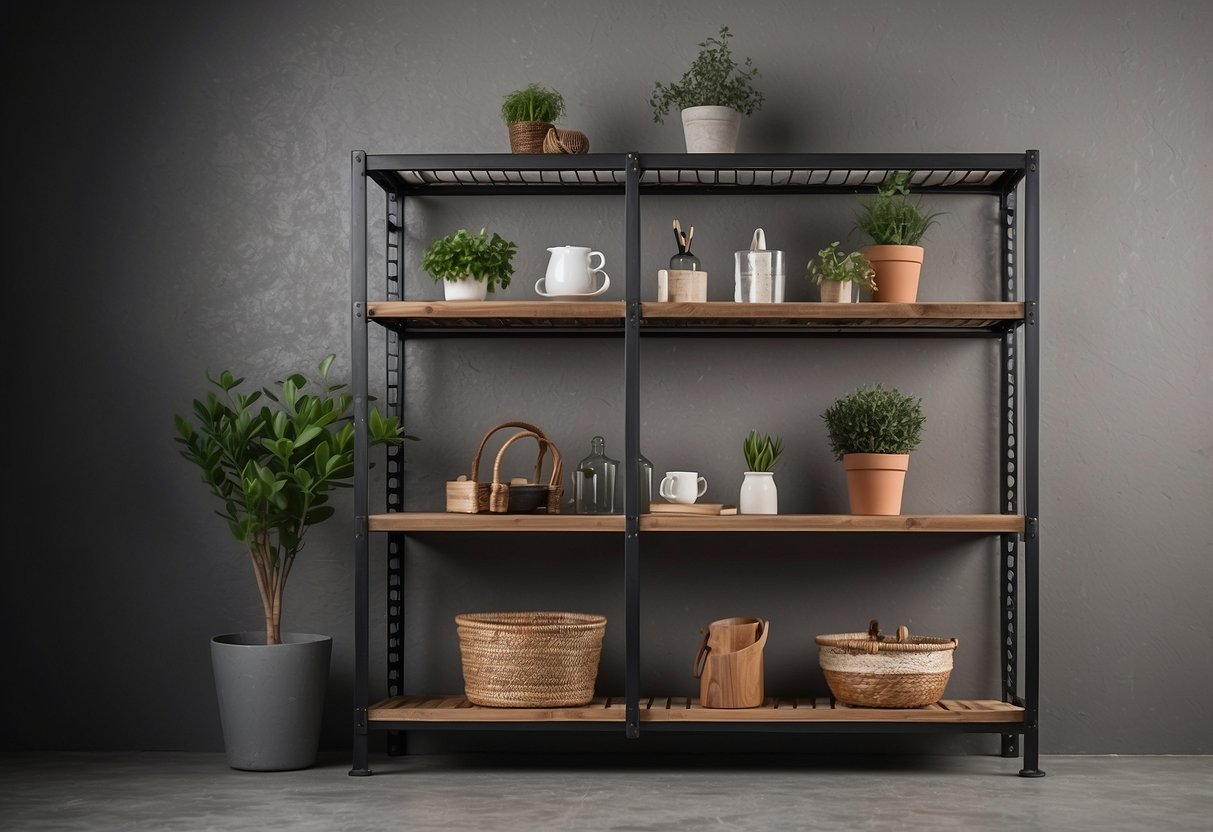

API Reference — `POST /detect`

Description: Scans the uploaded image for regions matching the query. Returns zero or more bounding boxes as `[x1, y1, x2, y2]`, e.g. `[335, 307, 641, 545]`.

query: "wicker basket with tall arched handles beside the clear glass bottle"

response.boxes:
[446, 422, 564, 514]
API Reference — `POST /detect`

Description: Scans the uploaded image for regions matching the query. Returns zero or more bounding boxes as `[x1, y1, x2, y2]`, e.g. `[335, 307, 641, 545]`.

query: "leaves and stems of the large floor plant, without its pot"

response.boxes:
[175, 354, 416, 644]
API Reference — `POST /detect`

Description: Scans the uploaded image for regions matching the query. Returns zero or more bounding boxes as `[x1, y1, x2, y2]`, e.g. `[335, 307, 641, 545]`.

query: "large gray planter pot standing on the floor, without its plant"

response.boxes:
[211, 632, 332, 771]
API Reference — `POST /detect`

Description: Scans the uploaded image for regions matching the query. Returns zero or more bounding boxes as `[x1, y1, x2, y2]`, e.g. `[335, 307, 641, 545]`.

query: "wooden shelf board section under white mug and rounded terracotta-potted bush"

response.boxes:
[640, 514, 1024, 534]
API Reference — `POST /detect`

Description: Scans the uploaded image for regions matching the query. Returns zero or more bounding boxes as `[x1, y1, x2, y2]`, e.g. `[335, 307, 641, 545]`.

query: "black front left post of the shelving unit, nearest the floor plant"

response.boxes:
[349, 150, 371, 776]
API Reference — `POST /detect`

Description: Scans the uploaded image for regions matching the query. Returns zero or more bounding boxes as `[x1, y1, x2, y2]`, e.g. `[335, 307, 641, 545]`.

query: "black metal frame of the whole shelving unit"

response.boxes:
[351, 150, 1044, 776]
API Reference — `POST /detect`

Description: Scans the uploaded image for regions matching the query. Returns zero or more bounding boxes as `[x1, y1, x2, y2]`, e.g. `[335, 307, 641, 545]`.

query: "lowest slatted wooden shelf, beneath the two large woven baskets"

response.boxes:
[370, 696, 1024, 723]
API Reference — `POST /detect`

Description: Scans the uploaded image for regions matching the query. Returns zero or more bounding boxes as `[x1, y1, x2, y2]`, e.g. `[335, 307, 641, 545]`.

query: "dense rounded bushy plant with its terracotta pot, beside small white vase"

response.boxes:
[821, 384, 926, 514]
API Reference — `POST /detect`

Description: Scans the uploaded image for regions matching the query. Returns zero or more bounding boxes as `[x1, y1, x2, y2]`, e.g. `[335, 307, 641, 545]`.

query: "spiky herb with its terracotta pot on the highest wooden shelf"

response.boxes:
[855, 171, 940, 303]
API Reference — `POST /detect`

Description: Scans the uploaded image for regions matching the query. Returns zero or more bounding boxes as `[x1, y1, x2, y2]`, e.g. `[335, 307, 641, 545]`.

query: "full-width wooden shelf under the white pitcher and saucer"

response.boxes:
[366, 301, 1024, 332]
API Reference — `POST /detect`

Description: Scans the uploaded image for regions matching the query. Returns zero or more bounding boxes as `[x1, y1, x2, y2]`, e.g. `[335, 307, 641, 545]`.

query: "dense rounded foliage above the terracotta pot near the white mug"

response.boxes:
[821, 384, 926, 460]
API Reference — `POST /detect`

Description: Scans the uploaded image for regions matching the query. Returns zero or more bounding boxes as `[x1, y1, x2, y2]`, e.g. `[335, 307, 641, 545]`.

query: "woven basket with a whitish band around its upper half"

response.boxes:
[816, 620, 958, 708]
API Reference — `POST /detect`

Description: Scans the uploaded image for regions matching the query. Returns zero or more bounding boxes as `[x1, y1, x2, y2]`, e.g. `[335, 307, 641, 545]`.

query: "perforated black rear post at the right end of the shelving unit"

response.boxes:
[996, 182, 1023, 758]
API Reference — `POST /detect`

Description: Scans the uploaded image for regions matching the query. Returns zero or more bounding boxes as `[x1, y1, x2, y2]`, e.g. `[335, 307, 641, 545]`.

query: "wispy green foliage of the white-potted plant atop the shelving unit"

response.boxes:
[649, 25, 763, 124]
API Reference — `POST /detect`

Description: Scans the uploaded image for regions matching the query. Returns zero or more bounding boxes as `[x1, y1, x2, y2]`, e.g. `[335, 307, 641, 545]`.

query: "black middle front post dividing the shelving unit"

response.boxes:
[623, 153, 640, 740]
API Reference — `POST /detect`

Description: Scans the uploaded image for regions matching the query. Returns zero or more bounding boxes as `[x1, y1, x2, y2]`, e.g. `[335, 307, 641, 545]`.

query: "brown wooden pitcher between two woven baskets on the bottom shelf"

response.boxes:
[693, 619, 770, 708]
